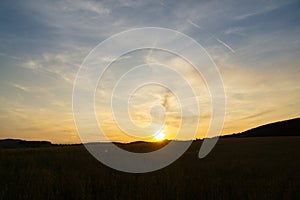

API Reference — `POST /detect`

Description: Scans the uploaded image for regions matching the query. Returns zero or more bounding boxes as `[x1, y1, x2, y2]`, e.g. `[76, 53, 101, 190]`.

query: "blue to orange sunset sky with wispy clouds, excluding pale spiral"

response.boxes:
[0, 0, 300, 143]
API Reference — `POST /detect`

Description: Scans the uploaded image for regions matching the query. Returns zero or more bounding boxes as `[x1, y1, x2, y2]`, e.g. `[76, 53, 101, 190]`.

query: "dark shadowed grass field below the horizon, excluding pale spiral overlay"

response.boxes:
[0, 137, 300, 199]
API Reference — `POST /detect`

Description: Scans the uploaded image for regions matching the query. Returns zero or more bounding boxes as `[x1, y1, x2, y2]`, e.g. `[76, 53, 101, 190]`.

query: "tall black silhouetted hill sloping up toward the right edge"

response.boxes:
[222, 118, 300, 138]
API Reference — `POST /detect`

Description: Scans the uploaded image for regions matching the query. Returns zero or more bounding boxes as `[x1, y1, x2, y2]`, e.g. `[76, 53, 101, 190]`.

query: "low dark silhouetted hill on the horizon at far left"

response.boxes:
[0, 139, 52, 148]
